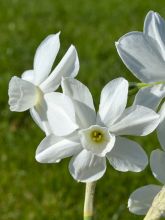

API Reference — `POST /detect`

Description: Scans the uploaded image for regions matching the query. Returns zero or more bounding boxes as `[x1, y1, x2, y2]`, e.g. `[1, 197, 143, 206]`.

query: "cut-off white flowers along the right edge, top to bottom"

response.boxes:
[116, 11, 165, 215]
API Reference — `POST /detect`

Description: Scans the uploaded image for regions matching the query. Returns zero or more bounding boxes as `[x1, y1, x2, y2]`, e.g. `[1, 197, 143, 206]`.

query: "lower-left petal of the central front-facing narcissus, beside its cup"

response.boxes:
[36, 135, 82, 163]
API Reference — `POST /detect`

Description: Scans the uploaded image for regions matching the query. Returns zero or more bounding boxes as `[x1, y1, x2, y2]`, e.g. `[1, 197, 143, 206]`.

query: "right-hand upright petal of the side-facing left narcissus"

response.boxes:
[40, 45, 79, 92]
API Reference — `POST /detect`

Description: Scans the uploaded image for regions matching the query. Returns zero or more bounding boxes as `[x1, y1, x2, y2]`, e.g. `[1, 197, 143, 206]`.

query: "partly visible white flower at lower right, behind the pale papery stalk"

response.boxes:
[128, 142, 165, 215]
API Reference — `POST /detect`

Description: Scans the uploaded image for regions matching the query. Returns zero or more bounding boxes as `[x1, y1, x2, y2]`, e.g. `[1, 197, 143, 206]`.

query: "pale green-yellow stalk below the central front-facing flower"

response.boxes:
[84, 182, 96, 220]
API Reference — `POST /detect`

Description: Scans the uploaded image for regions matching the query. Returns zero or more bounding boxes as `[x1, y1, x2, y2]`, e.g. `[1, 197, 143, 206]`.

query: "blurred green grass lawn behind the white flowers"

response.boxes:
[0, 0, 165, 220]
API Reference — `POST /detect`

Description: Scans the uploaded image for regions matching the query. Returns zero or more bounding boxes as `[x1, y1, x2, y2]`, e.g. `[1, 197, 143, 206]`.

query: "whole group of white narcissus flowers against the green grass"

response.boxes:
[9, 9, 165, 218]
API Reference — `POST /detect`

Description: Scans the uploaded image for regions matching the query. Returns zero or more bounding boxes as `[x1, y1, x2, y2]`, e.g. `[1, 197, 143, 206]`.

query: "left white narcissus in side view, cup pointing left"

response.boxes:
[8, 33, 79, 134]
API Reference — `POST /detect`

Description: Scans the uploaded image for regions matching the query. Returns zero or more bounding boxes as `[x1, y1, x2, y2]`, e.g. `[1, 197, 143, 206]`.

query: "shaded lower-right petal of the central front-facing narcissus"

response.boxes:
[106, 137, 148, 172]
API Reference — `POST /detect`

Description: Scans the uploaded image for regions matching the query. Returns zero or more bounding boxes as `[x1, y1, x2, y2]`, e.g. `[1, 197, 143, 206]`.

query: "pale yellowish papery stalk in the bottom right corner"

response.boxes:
[144, 186, 165, 220]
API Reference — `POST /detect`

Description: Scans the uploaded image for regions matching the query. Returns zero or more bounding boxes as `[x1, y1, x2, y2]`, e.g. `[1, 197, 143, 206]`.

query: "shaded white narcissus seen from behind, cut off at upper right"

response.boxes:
[116, 11, 165, 150]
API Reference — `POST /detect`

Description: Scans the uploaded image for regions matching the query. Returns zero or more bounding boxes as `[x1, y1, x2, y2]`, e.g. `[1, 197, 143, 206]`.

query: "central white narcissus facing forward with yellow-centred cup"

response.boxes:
[36, 78, 159, 182]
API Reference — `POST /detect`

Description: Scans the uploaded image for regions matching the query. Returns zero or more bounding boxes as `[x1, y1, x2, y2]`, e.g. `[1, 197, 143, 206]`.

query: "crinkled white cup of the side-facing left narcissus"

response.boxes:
[8, 76, 38, 112]
